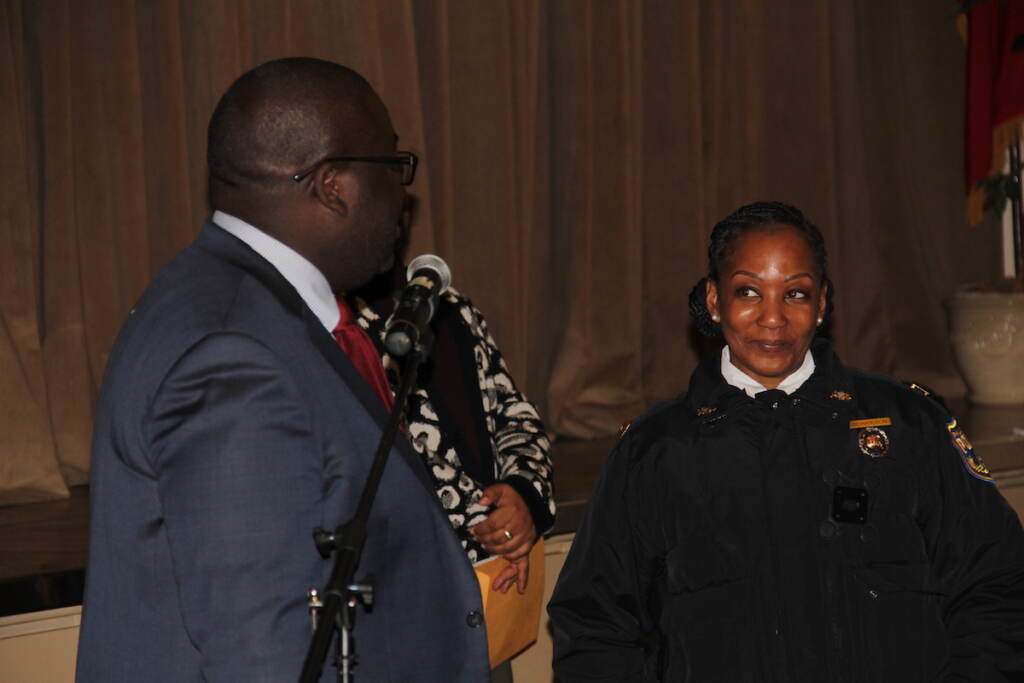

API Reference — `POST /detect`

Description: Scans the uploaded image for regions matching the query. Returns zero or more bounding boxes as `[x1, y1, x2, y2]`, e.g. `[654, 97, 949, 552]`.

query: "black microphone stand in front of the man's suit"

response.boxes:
[299, 327, 433, 683]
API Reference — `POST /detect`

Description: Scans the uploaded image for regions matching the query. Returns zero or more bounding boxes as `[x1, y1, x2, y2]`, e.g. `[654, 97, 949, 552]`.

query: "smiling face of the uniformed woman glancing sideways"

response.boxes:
[707, 224, 825, 389]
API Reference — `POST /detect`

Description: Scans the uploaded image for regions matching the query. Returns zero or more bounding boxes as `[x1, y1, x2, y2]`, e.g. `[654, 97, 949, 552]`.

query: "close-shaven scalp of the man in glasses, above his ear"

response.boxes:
[207, 57, 378, 196]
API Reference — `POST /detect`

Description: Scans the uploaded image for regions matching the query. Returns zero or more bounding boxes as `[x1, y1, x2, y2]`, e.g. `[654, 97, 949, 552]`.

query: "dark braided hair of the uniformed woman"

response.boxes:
[689, 202, 836, 337]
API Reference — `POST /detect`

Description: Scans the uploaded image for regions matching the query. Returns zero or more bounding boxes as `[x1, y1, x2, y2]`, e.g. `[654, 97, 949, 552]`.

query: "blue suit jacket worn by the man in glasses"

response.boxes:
[78, 223, 487, 683]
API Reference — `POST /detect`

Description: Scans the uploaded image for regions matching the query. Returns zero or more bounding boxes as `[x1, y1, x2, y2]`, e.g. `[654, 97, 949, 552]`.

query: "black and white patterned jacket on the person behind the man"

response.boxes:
[353, 288, 555, 562]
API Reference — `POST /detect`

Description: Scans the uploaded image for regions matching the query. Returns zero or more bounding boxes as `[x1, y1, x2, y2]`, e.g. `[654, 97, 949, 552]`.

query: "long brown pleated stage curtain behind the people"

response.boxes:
[0, 0, 997, 504]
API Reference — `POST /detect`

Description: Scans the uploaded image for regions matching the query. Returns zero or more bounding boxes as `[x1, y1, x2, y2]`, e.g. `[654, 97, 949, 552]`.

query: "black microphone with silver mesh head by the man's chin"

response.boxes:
[384, 254, 452, 357]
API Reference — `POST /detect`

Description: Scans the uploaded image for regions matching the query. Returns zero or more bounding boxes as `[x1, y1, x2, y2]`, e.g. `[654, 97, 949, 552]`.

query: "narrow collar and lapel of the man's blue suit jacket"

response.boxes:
[196, 221, 436, 496]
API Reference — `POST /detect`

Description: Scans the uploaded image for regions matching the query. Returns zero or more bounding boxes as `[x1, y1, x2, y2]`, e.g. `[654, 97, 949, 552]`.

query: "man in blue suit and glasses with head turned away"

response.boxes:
[78, 58, 487, 683]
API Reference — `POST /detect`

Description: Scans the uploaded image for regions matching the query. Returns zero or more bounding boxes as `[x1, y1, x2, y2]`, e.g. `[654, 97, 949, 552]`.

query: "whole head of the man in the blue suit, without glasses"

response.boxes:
[207, 57, 406, 292]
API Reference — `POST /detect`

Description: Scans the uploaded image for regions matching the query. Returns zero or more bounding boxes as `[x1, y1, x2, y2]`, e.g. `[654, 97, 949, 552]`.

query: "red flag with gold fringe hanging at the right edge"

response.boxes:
[961, 0, 1024, 225]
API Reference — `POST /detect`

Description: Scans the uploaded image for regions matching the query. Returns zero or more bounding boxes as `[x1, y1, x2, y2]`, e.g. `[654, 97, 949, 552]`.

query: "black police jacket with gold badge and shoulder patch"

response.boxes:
[549, 341, 1024, 683]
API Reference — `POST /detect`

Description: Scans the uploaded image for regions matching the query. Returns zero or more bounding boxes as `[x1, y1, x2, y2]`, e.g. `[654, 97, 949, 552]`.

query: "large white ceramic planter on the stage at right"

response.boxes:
[949, 292, 1024, 405]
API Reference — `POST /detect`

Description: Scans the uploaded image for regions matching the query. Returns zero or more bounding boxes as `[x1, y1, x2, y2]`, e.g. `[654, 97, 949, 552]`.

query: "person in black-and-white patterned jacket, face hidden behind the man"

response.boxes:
[352, 259, 555, 592]
